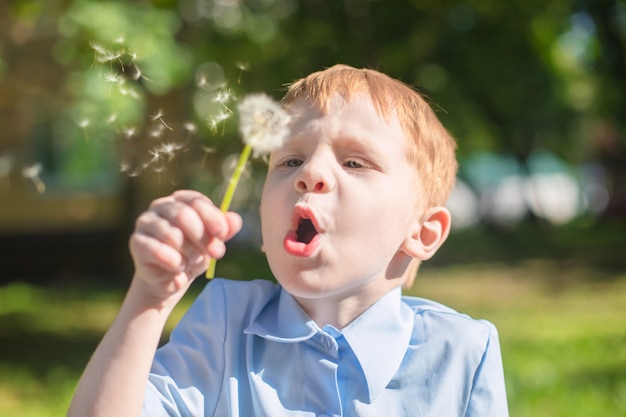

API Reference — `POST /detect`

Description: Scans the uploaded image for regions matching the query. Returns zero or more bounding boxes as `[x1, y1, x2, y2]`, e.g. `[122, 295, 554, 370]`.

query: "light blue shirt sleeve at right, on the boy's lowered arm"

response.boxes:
[465, 322, 509, 417]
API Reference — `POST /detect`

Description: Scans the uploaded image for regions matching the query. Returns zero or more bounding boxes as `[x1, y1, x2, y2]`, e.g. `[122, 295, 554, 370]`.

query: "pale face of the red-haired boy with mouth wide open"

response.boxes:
[261, 94, 419, 302]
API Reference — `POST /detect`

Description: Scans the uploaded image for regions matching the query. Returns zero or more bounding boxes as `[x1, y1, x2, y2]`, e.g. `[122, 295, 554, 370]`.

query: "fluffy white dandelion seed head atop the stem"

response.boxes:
[237, 93, 291, 156]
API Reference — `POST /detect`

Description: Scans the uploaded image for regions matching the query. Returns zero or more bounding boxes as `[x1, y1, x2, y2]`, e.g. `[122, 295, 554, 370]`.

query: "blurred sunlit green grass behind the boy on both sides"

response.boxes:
[0, 242, 626, 417]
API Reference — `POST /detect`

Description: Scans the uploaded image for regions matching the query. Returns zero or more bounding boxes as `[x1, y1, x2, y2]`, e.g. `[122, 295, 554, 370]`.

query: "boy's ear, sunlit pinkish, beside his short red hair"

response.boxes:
[402, 207, 451, 261]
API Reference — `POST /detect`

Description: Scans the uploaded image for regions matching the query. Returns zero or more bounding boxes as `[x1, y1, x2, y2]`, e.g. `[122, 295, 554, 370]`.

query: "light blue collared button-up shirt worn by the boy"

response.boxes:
[143, 279, 508, 417]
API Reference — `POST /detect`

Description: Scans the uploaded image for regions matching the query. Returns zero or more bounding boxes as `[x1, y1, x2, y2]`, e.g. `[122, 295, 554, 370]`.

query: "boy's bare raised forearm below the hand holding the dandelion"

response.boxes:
[67, 283, 171, 417]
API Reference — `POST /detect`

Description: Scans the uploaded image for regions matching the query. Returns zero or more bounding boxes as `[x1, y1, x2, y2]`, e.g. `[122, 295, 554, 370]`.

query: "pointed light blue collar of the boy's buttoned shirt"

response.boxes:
[244, 287, 414, 401]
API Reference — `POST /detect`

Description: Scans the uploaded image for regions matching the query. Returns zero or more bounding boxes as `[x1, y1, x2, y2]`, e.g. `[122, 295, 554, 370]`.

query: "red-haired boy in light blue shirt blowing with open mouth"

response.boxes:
[68, 65, 508, 417]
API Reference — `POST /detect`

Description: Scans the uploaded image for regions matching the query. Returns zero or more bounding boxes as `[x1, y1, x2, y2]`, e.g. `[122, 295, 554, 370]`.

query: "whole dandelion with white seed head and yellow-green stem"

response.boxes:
[206, 93, 291, 279]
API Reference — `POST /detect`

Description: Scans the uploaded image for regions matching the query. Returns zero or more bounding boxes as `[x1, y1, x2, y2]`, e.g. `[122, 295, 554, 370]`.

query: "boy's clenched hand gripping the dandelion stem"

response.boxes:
[130, 190, 242, 304]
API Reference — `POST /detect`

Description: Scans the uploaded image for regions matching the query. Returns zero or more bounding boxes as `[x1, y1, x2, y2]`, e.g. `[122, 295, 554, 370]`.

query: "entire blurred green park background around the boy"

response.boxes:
[0, 0, 626, 417]
